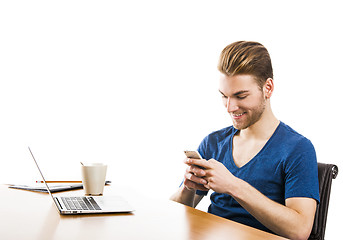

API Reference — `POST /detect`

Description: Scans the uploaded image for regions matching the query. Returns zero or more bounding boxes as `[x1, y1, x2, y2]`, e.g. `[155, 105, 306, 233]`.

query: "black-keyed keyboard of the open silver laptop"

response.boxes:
[62, 197, 101, 210]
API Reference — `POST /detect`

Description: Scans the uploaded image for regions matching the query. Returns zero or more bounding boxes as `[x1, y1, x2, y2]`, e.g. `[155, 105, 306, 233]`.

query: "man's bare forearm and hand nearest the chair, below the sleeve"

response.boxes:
[188, 159, 316, 239]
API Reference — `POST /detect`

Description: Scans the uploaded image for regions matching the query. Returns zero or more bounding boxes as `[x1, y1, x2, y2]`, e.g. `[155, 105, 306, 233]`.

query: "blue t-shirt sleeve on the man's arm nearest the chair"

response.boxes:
[285, 139, 320, 203]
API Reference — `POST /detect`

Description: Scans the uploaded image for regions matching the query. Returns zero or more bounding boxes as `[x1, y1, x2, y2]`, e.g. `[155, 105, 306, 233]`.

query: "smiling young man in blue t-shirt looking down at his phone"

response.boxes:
[171, 41, 319, 239]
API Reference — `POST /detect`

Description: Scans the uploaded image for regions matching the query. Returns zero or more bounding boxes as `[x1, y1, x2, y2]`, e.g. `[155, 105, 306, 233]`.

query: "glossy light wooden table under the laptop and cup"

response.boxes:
[0, 185, 284, 240]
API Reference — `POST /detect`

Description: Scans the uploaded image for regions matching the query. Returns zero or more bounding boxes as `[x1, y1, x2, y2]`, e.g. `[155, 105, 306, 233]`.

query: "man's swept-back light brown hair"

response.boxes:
[218, 41, 273, 89]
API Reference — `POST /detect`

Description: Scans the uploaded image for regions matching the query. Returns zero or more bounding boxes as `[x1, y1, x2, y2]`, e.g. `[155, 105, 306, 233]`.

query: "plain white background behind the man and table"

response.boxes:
[0, 0, 343, 239]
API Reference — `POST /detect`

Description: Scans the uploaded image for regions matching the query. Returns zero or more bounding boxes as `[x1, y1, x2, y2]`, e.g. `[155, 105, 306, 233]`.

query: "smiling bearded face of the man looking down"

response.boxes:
[219, 74, 266, 130]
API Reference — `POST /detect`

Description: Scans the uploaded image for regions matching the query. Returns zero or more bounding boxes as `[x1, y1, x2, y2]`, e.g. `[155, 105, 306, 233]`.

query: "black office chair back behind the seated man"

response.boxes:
[309, 163, 338, 240]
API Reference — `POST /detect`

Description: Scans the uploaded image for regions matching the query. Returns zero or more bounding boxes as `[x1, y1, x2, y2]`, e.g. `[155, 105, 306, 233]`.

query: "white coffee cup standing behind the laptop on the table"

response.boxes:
[81, 163, 107, 196]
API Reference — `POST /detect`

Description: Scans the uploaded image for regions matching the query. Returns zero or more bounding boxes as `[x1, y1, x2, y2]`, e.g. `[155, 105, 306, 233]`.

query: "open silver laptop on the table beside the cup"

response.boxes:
[29, 147, 134, 214]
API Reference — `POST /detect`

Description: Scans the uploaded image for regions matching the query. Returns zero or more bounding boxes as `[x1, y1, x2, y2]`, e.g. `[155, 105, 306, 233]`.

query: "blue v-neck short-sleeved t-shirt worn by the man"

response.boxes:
[197, 122, 319, 232]
